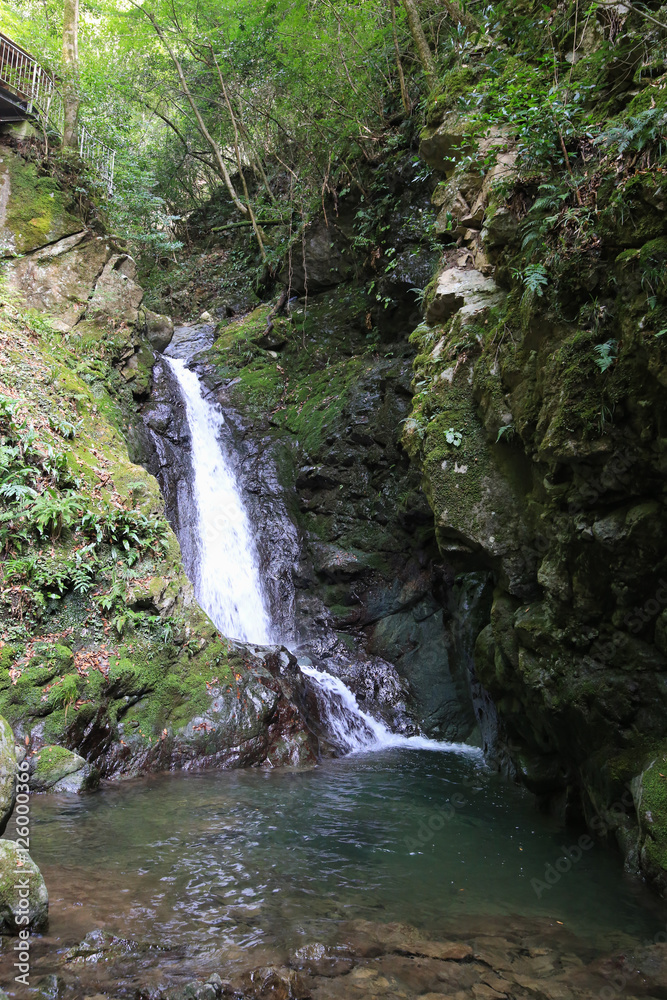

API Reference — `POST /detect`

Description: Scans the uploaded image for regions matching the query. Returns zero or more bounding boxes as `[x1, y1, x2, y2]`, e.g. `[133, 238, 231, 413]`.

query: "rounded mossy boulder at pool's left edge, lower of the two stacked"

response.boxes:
[0, 840, 49, 934]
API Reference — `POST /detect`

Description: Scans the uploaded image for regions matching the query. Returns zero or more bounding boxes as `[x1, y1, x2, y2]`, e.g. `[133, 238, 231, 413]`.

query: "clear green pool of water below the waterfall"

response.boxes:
[0, 749, 667, 982]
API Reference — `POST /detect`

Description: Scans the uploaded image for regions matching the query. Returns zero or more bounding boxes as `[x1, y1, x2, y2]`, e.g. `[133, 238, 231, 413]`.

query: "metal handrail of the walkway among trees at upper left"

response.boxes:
[0, 32, 116, 194]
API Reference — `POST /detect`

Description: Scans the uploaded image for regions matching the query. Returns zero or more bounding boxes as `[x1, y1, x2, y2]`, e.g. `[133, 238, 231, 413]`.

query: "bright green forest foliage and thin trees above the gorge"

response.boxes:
[2, 0, 667, 282]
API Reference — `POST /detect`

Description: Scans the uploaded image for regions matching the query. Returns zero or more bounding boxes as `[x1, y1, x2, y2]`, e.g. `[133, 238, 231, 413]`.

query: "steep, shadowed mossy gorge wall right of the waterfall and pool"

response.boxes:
[403, 48, 667, 889]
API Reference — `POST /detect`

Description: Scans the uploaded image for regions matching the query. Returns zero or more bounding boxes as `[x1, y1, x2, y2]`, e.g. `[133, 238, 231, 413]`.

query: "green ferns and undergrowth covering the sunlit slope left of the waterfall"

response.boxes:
[0, 292, 175, 642]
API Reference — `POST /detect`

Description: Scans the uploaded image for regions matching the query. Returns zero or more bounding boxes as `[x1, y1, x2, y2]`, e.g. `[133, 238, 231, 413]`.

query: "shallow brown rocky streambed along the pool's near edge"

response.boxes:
[14, 917, 667, 1000]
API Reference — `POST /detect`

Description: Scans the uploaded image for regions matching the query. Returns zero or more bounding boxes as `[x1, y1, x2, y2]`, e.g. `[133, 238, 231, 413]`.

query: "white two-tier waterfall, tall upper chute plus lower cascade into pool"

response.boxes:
[164, 348, 472, 755]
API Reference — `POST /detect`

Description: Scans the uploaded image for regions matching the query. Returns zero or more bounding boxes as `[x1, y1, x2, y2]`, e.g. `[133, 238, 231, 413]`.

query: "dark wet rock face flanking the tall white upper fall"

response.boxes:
[143, 288, 475, 740]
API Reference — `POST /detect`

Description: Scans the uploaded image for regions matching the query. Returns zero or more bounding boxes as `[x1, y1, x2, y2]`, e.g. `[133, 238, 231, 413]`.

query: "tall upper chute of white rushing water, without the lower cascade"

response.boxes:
[164, 358, 273, 644]
